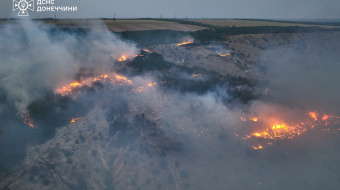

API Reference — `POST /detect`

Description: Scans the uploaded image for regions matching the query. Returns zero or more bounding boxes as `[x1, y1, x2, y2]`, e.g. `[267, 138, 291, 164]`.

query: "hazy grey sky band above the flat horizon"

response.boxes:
[0, 0, 340, 19]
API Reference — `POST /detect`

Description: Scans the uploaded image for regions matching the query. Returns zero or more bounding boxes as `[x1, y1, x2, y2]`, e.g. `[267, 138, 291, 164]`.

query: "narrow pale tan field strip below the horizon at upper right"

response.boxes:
[191, 19, 339, 28]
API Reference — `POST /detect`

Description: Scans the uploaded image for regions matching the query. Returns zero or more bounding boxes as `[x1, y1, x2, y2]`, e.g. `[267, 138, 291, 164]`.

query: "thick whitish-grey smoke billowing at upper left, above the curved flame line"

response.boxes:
[0, 20, 137, 113]
